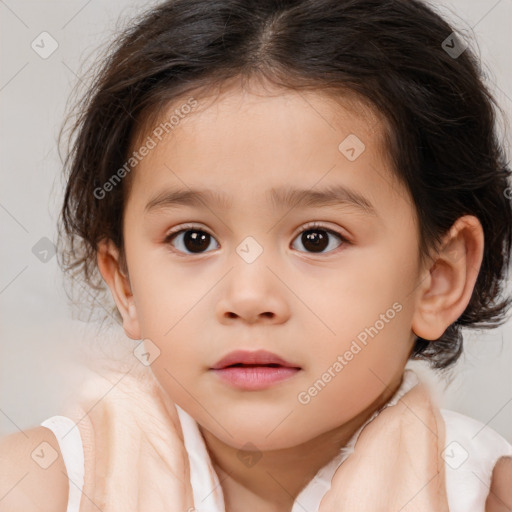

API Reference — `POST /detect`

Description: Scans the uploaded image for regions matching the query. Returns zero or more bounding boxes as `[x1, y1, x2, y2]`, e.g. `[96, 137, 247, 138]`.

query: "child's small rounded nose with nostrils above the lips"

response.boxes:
[217, 258, 290, 324]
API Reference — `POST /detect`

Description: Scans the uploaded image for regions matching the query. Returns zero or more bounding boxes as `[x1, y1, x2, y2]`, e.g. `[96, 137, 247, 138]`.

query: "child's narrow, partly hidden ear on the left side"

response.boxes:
[97, 239, 141, 340]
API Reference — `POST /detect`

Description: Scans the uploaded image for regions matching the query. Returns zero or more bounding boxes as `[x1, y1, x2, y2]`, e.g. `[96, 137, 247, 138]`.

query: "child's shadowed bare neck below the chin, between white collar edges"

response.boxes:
[199, 376, 401, 512]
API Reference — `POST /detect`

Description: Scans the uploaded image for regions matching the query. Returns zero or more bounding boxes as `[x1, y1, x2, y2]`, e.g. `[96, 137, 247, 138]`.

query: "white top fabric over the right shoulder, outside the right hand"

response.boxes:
[441, 409, 512, 512]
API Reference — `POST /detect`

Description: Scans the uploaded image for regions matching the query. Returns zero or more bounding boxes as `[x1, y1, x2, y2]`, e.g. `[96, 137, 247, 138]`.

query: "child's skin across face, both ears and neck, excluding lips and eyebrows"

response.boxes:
[98, 77, 508, 512]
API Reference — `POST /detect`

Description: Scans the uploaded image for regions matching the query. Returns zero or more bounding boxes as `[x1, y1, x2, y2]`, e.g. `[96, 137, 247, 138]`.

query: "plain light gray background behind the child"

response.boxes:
[0, 0, 512, 442]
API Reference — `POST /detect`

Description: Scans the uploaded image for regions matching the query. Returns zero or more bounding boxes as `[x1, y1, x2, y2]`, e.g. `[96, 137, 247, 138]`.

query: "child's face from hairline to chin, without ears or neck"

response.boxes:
[105, 80, 428, 449]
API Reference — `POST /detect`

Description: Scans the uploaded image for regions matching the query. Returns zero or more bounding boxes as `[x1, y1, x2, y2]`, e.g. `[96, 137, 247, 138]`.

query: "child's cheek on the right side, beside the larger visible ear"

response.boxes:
[300, 251, 416, 404]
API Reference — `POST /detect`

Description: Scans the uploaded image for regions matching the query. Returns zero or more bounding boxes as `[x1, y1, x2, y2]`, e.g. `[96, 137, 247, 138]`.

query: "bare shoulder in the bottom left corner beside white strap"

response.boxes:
[0, 426, 69, 512]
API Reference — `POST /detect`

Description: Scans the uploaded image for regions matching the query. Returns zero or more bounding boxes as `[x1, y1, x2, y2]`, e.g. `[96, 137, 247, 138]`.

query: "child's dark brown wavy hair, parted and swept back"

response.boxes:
[58, 0, 512, 368]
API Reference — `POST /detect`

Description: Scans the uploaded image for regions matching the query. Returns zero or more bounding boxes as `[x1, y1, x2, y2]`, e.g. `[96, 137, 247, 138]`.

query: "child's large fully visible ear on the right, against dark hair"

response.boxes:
[412, 215, 484, 340]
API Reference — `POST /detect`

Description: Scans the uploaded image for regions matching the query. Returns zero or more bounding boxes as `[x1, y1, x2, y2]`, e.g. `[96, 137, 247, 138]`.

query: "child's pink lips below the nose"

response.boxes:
[210, 350, 301, 391]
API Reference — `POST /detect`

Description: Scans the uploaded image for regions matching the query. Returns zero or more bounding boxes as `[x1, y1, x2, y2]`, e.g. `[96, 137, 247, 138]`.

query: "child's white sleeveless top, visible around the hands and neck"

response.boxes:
[41, 370, 512, 512]
